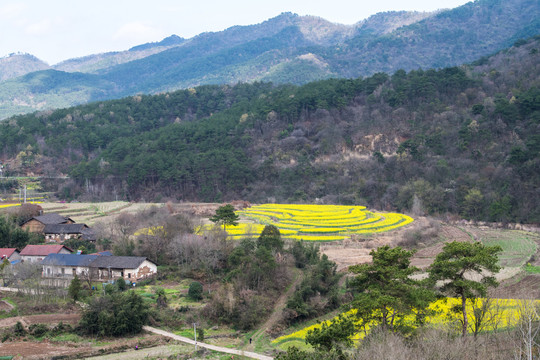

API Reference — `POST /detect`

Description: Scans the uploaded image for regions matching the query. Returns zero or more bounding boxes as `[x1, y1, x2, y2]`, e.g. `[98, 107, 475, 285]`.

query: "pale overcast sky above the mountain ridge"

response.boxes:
[0, 0, 467, 65]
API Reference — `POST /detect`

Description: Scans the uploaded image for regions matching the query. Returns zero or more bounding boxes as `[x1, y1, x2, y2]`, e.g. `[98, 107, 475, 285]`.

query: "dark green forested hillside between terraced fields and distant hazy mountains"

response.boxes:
[0, 37, 540, 222]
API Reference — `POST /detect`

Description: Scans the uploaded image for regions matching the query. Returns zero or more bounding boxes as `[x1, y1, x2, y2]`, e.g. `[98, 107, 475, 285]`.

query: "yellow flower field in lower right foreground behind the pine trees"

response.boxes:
[272, 298, 540, 344]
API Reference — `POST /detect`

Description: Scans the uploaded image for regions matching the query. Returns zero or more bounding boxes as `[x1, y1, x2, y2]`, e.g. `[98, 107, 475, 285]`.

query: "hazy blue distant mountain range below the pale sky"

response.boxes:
[0, 0, 540, 119]
